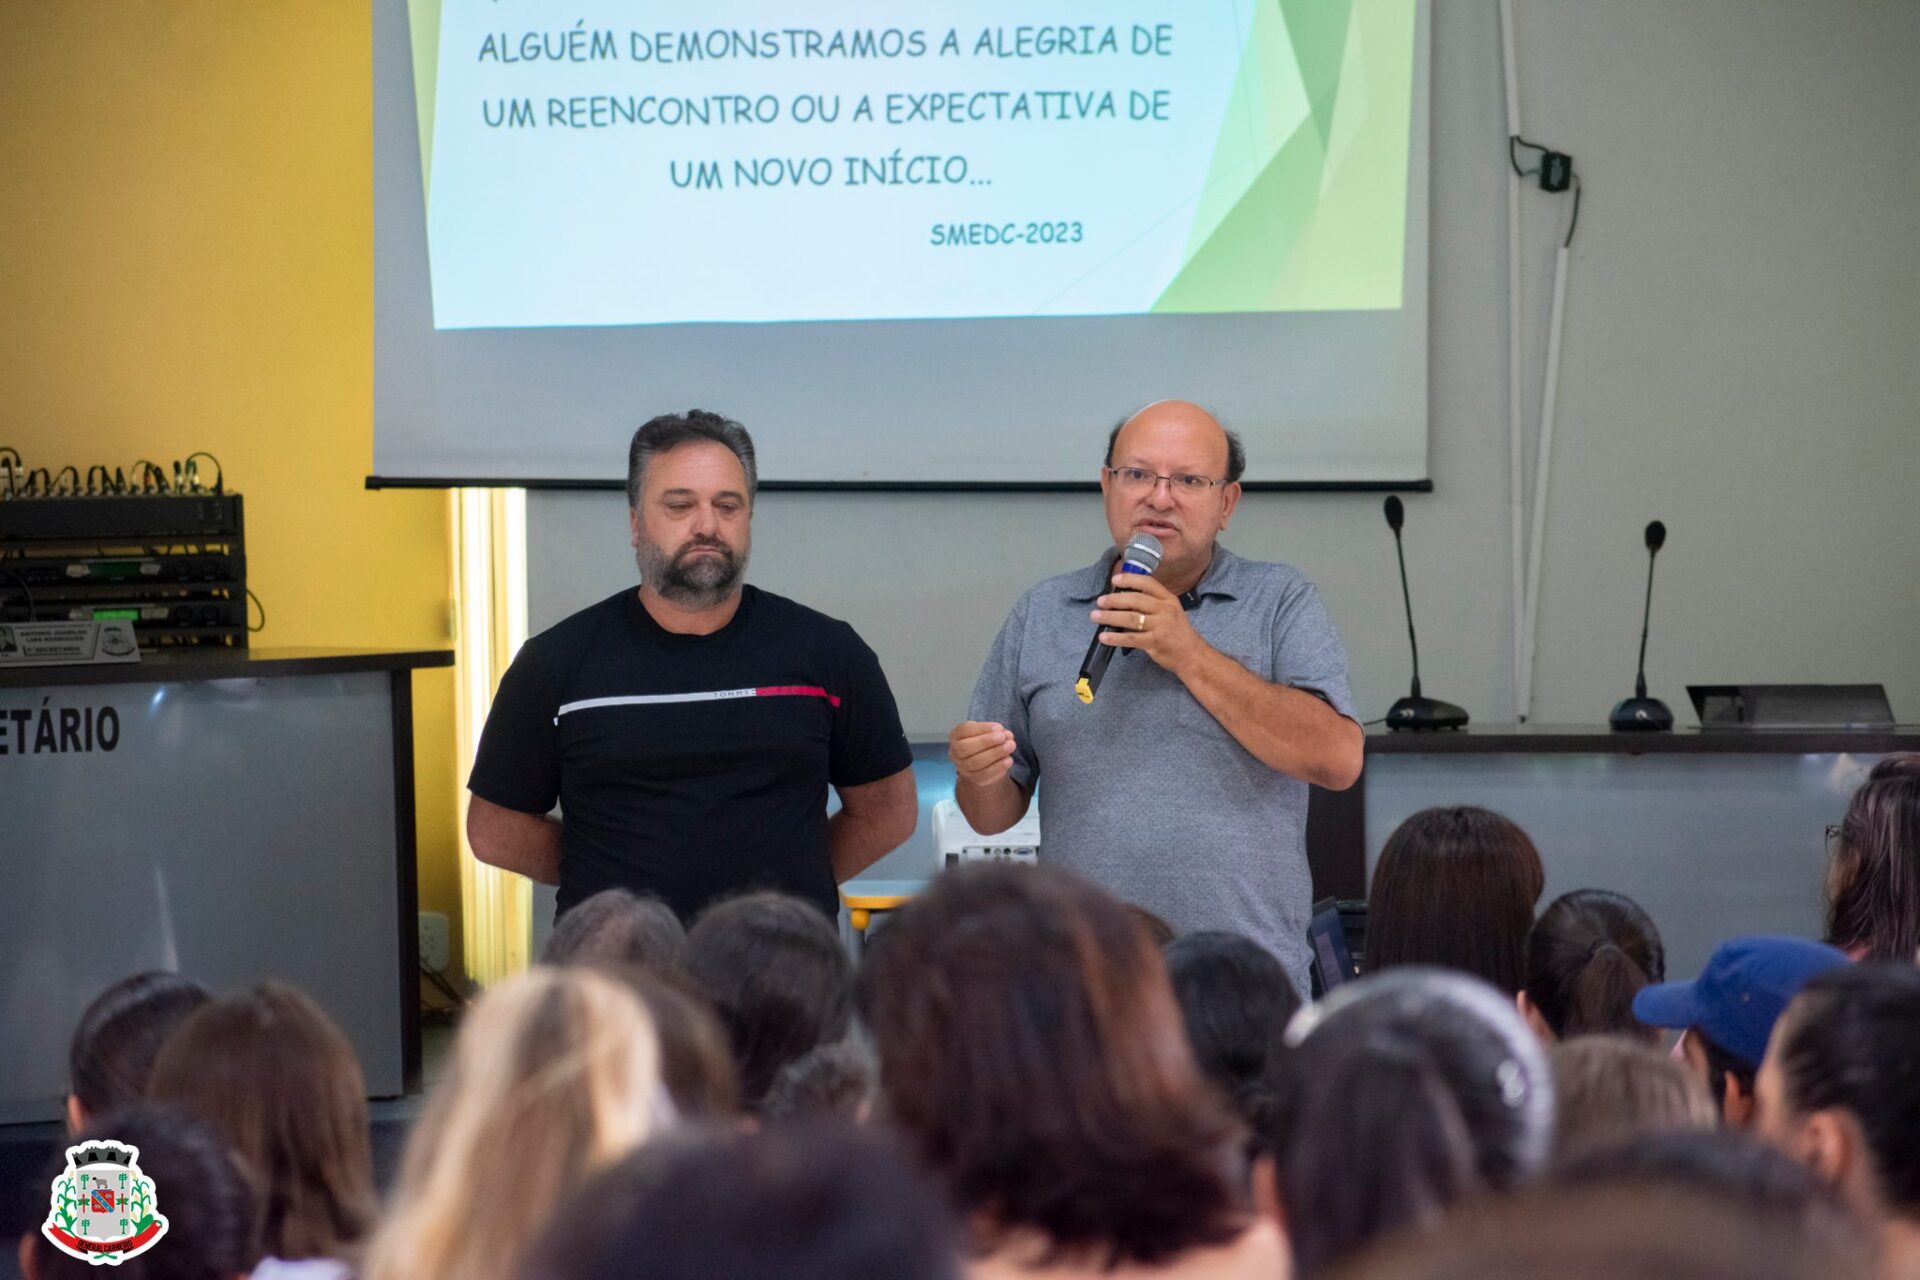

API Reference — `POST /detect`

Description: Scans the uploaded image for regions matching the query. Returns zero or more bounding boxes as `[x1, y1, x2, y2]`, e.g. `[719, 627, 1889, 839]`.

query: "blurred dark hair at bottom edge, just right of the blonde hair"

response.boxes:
[520, 1125, 960, 1280]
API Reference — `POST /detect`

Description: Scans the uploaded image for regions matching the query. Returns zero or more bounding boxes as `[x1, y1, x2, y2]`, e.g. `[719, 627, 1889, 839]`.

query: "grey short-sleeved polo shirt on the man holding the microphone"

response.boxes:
[968, 545, 1357, 994]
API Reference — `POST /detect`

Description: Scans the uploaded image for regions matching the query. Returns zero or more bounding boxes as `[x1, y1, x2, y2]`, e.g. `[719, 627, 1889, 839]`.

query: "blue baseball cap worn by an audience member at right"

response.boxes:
[1634, 936, 1851, 1067]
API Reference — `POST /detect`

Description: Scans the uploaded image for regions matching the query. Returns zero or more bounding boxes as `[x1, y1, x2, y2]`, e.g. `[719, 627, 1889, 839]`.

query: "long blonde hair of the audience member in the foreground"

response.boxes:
[361, 967, 670, 1280]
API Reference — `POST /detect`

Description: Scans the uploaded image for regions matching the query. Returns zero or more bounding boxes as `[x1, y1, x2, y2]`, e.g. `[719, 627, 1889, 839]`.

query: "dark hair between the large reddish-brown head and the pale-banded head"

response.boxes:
[1162, 929, 1300, 1103]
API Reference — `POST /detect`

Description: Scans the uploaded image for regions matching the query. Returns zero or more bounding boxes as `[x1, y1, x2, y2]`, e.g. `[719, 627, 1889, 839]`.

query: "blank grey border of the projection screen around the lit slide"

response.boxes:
[367, 0, 1432, 493]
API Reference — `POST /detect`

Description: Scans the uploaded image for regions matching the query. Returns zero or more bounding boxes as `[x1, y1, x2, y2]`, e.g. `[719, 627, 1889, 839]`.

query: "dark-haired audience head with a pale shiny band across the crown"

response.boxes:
[1260, 965, 1553, 1276]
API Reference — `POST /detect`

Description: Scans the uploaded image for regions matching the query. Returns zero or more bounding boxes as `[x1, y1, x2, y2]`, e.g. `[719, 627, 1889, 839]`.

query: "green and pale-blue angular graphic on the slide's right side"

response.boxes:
[1152, 0, 1415, 313]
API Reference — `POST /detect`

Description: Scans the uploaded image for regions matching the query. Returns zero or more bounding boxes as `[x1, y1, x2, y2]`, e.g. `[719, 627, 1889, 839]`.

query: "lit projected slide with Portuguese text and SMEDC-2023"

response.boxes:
[409, 0, 1415, 330]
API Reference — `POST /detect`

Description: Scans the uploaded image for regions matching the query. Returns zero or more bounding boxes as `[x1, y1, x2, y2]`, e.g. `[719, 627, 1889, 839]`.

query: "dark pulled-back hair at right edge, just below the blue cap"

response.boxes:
[1776, 963, 1920, 1217]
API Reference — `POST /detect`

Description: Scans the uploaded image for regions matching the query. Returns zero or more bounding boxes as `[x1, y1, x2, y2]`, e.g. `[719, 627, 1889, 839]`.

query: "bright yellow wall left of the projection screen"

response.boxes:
[0, 0, 461, 971]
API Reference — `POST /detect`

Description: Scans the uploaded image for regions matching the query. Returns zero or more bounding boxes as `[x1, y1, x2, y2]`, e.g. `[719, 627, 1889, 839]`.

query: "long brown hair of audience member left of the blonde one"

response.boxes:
[148, 983, 376, 1261]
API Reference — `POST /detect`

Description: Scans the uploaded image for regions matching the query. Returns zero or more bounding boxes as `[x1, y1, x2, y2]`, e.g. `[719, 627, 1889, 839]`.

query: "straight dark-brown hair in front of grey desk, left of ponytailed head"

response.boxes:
[1367, 804, 1546, 996]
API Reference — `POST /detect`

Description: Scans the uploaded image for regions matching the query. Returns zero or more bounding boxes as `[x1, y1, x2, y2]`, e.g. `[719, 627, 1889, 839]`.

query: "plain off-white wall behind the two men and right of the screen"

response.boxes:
[528, 0, 1920, 735]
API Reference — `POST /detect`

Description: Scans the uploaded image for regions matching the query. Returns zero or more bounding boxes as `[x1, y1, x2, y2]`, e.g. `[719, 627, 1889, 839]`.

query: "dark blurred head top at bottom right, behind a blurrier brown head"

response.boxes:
[1551, 1128, 1874, 1274]
